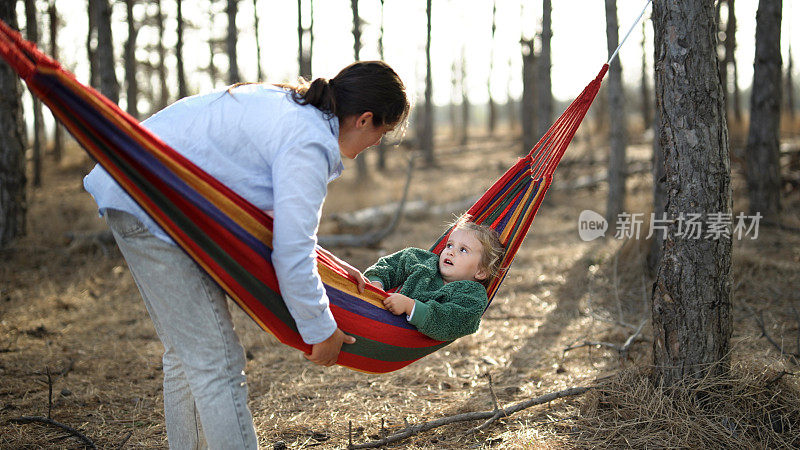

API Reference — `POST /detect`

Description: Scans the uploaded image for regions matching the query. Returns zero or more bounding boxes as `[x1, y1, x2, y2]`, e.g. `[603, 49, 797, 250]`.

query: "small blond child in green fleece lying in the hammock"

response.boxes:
[364, 217, 503, 341]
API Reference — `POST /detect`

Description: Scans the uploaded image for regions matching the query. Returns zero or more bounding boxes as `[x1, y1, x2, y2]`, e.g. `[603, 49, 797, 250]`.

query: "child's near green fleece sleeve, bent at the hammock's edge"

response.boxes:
[409, 281, 489, 341]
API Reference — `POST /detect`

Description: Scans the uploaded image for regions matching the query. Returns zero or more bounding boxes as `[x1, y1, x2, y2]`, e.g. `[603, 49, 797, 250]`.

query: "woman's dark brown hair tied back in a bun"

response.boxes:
[278, 61, 411, 126]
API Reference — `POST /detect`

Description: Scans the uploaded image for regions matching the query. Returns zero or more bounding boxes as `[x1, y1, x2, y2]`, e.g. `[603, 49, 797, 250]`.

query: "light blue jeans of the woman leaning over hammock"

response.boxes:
[106, 210, 258, 449]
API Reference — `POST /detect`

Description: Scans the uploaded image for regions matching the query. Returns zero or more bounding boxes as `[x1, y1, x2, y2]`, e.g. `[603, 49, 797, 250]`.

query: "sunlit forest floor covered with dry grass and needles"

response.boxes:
[0, 124, 800, 449]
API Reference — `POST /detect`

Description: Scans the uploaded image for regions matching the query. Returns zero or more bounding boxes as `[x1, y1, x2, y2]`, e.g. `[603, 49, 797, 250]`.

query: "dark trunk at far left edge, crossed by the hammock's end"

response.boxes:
[0, 1, 27, 248]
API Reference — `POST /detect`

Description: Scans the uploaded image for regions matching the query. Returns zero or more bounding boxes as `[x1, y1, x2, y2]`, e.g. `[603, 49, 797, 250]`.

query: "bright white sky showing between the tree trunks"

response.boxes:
[10, 0, 800, 108]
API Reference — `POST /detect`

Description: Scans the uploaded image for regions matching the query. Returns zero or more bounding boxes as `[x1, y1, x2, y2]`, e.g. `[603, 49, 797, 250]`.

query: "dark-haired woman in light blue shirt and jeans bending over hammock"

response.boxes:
[84, 61, 409, 449]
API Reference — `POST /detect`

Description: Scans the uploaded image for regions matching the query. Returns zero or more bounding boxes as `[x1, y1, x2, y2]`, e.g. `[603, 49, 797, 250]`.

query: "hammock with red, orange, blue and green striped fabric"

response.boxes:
[0, 21, 608, 373]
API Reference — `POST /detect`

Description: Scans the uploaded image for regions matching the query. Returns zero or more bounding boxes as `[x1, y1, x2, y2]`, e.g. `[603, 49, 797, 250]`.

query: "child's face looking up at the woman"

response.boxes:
[439, 228, 487, 283]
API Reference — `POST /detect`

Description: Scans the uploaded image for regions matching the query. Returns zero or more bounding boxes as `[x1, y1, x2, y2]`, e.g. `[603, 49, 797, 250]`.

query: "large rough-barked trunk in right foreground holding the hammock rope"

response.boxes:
[652, 0, 731, 386]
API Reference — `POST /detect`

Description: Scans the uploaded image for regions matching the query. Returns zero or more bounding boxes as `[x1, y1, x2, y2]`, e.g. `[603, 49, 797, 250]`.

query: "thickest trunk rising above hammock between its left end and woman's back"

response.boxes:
[89, 0, 119, 103]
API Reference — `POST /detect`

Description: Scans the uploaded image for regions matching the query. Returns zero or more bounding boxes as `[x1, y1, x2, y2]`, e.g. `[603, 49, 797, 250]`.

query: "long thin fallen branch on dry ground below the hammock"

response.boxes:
[349, 387, 590, 449]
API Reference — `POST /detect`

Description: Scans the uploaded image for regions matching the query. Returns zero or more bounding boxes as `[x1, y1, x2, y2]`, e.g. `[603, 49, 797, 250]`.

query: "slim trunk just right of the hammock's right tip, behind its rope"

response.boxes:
[606, 0, 627, 227]
